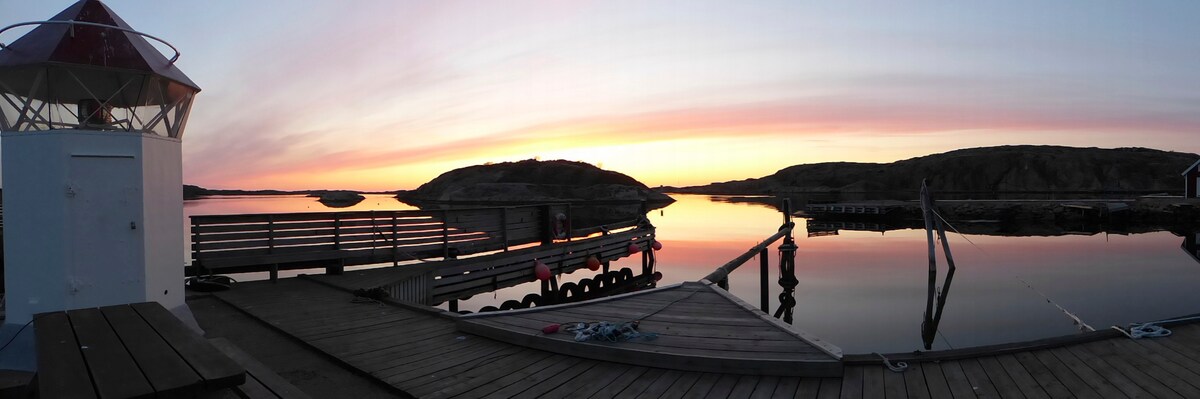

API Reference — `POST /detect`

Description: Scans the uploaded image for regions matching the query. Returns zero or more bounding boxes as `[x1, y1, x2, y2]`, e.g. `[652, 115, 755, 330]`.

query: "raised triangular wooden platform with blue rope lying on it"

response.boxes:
[458, 282, 841, 377]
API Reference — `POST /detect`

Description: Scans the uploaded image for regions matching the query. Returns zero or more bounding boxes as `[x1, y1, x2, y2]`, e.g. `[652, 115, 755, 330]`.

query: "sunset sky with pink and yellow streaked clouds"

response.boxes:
[0, 0, 1200, 190]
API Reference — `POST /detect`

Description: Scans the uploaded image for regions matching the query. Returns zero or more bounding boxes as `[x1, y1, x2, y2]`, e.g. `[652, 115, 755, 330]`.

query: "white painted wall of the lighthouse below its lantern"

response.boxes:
[0, 130, 186, 324]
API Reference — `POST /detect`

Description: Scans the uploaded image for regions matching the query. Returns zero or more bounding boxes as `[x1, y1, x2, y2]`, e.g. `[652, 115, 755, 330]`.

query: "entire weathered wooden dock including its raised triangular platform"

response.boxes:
[180, 203, 1200, 399]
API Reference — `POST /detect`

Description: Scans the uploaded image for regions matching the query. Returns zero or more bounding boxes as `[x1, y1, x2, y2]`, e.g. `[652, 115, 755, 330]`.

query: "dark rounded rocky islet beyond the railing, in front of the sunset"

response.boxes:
[396, 160, 674, 204]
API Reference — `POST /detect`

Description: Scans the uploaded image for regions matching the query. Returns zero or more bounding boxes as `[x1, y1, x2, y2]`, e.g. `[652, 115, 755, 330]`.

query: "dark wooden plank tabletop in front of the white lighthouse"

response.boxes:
[34, 302, 246, 398]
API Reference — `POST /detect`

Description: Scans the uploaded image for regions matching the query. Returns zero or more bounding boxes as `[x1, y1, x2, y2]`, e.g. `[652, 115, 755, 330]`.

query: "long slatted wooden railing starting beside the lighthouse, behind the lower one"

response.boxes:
[190, 204, 609, 274]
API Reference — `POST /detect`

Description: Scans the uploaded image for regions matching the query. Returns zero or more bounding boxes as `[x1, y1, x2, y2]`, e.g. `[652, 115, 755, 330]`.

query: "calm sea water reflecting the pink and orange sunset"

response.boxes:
[185, 195, 1200, 353]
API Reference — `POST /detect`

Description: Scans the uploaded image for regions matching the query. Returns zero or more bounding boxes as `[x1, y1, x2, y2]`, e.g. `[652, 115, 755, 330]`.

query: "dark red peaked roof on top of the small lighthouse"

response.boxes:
[0, 0, 200, 91]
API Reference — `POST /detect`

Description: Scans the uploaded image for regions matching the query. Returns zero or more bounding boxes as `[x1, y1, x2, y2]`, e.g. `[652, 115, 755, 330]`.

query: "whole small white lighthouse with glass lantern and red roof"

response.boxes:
[0, 0, 200, 367]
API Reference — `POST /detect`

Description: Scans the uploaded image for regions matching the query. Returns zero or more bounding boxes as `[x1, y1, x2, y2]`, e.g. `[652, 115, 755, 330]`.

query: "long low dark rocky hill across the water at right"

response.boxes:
[671, 145, 1200, 195]
